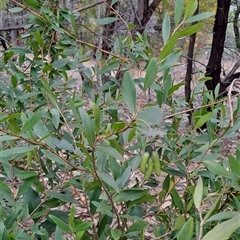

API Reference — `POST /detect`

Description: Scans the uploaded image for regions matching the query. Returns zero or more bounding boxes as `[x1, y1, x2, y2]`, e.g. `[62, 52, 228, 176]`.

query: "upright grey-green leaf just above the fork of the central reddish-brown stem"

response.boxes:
[79, 107, 95, 147]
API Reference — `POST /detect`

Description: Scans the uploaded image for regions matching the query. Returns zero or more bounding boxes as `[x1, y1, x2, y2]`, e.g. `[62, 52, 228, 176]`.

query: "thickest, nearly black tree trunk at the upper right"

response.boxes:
[205, 0, 231, 97]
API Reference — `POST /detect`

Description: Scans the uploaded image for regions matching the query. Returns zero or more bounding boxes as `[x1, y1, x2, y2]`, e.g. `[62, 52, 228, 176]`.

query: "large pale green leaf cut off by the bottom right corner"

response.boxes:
[202, 213, 240, 240]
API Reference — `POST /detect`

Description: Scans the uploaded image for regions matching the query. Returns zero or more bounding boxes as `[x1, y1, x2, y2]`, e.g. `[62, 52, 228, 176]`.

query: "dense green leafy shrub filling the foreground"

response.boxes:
[0, 0, 240, 240]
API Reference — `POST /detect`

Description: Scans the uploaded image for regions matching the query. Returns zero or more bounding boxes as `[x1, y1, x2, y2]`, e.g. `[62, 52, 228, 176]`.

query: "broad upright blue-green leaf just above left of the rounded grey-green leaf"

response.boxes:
[122, 72, 137, 114]
